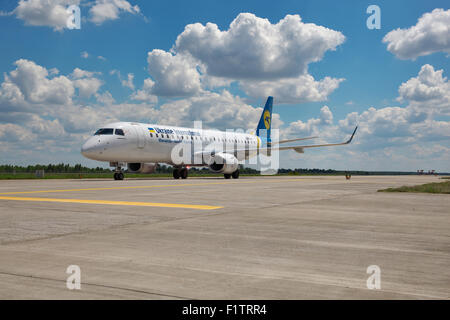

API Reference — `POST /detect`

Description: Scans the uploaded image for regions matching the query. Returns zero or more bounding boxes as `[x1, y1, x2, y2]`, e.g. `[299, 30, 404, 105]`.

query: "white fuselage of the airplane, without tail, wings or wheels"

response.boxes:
[81, 122, 261, 166]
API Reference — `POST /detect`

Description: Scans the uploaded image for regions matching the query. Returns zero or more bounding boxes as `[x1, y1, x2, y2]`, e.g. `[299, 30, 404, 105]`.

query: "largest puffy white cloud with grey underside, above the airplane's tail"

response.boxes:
[141, 13, 345, 103]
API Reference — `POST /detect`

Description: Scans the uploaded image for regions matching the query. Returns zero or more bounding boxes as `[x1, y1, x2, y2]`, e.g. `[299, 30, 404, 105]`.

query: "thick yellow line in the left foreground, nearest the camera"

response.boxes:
[0, 196, 223, 210]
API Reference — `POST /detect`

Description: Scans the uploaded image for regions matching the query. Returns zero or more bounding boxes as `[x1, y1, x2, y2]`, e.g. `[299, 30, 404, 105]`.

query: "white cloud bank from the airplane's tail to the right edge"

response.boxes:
[282, 65, 450, 171]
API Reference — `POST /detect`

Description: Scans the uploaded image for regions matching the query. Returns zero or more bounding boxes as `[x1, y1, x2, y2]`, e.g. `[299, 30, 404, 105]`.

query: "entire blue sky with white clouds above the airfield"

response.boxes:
[0, 0, 450, 172]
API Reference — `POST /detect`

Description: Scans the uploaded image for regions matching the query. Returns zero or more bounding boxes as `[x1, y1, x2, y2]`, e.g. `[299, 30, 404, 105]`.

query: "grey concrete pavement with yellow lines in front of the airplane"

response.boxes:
[0, 176, 450, 299]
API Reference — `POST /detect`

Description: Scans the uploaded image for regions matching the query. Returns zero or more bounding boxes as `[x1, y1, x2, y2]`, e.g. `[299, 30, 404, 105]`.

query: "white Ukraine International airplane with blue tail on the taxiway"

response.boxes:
[81, 96, 358, 180]
